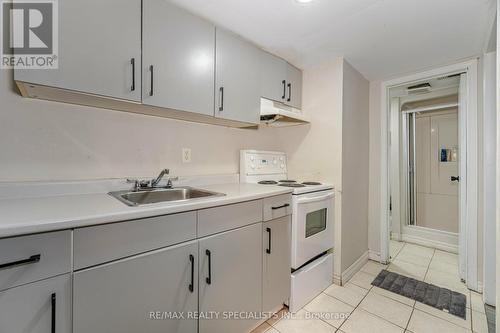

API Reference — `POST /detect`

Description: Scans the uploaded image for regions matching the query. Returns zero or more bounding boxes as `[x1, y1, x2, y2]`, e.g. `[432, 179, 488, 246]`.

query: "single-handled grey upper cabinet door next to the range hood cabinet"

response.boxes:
[215, 28, 261, 124]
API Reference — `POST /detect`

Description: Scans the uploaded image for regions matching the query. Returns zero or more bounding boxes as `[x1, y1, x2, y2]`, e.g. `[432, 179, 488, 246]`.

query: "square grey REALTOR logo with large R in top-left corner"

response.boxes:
[1, 0, 58, 69]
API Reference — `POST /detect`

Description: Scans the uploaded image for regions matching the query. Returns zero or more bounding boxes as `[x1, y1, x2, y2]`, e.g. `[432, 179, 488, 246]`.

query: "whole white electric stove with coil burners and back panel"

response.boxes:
[240, 150, 335, 312]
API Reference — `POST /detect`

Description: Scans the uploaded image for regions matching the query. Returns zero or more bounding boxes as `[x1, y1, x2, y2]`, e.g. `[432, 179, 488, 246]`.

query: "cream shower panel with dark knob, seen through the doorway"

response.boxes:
[415, 109, 460, 234]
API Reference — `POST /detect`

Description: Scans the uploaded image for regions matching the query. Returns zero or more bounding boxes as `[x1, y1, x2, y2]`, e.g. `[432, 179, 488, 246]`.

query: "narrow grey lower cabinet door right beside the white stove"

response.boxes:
[262, 215, 291, 312]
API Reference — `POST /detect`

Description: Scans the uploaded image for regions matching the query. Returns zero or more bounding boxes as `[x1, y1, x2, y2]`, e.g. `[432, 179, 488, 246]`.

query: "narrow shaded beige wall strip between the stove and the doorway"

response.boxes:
[341, 61, 370, 271]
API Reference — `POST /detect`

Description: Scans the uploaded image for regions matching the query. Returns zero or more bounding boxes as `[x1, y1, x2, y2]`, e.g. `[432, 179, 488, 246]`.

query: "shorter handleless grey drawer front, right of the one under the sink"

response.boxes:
[198, 200, 262, 237]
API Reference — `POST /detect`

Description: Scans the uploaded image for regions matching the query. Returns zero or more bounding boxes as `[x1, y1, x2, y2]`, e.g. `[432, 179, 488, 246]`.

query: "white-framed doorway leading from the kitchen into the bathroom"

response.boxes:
[380, 61, 478, 290]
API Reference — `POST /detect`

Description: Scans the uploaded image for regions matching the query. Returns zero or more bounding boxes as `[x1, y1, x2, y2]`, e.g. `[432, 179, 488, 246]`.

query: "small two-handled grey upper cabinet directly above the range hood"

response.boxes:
[261, 51, 302, 109]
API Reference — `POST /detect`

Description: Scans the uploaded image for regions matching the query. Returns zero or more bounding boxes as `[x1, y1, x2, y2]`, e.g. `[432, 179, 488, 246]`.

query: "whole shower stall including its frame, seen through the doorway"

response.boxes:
[400, 95, 460, 240]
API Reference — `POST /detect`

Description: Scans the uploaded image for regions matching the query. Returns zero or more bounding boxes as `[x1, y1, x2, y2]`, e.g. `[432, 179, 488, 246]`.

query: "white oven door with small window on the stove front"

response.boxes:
[292, 190, 335, 269]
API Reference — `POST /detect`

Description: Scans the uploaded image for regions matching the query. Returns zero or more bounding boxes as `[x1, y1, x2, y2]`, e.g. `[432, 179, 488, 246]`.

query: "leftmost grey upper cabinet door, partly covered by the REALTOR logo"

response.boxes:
[14, 0, 141, 102]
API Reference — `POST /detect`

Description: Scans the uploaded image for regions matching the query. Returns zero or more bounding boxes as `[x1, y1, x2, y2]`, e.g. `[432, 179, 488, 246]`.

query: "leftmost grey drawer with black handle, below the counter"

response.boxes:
[0, 230, 71, 290]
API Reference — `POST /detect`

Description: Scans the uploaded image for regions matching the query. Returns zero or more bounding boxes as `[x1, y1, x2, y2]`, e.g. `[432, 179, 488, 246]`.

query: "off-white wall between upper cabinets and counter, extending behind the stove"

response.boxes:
[0, 58, 348, 186]
